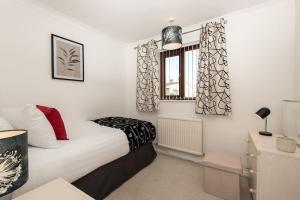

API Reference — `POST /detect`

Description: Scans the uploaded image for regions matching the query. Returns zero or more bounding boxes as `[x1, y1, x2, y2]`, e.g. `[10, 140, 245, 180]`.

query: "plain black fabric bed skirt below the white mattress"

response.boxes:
[72, 143, 157, 200]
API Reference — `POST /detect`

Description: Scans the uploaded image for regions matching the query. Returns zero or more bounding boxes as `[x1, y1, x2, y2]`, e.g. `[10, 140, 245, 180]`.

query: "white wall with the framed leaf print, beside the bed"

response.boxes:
[0, 0, 125, 125]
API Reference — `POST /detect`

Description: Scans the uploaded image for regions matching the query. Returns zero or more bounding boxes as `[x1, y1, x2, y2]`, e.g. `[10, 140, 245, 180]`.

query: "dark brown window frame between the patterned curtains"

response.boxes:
[160, 44, 199, 101]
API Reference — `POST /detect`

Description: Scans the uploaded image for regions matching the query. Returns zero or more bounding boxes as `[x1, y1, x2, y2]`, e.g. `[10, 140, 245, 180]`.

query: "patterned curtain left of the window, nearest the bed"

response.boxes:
[136, 40, 159, 112]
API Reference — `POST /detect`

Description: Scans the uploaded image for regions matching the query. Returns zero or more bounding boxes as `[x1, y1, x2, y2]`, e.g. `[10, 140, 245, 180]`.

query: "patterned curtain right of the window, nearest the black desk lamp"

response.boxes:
[196, 19, 231, 116]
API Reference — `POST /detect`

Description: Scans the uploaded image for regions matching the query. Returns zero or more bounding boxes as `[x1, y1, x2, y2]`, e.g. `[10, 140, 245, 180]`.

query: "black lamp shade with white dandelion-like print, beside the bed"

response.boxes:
[0, 130, 28, 197]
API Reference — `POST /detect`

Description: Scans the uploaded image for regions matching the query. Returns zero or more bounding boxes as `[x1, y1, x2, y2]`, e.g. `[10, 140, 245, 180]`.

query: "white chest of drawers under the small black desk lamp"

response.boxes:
[246, 131, 300, 200]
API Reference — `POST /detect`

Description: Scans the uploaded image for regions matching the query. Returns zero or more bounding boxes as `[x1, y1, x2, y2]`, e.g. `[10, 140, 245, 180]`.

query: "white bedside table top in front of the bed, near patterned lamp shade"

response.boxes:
[14, 178, 94, 200]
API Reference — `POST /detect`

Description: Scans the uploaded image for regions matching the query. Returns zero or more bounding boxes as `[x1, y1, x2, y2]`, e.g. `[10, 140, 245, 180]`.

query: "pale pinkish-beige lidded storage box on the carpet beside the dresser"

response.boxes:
[201, 153, 242, 200]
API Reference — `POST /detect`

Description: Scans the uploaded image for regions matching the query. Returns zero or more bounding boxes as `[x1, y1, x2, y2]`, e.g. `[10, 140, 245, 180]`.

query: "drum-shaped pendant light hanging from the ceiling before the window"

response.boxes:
[161, 19, 182, 50]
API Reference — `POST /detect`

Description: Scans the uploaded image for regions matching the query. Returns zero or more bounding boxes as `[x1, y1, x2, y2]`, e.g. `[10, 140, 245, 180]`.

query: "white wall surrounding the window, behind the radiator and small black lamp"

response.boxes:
[124, 0, 295, 159]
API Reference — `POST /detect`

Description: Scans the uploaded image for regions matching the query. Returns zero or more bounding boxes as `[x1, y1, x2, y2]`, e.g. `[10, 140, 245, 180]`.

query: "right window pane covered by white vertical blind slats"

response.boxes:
[184, 49, 199, 98]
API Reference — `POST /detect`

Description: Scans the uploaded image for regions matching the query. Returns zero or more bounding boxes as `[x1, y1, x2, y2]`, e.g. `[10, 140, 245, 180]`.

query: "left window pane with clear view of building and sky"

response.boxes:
[165, 56, 179, 96]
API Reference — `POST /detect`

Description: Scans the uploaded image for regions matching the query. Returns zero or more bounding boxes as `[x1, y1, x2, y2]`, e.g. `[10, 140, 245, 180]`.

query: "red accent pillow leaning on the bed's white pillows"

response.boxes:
[36, 105, 68, 140]
